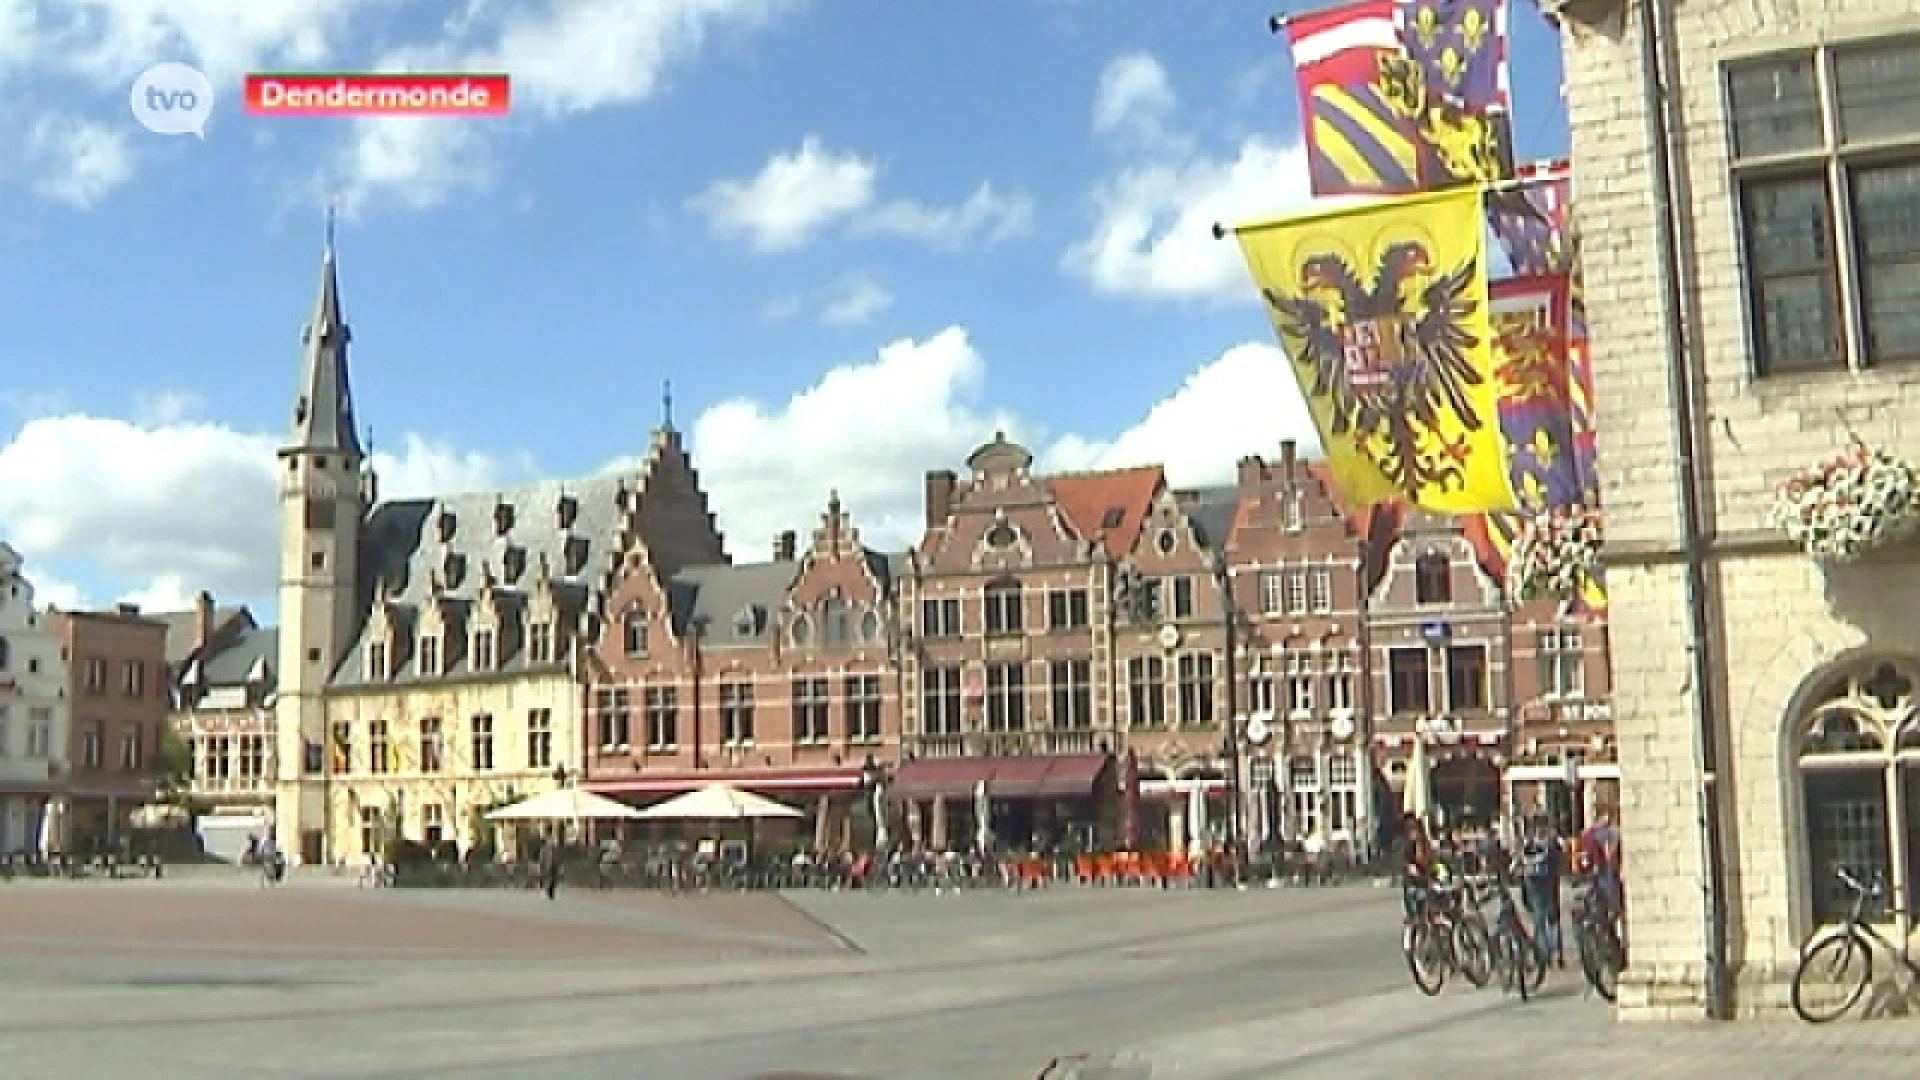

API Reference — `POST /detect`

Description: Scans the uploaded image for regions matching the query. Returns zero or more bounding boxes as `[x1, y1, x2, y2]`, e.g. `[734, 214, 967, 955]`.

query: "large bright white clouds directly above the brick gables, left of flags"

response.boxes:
[693, 327, 1315, 545]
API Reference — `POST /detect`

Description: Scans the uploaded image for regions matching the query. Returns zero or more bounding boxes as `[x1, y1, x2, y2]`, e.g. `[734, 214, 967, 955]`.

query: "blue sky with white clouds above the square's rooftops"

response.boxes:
[0, 0, 1567, 617]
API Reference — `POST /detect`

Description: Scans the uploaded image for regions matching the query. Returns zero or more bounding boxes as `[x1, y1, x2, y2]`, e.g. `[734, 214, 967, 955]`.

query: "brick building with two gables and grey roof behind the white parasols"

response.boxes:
[584, 496, 900, 844]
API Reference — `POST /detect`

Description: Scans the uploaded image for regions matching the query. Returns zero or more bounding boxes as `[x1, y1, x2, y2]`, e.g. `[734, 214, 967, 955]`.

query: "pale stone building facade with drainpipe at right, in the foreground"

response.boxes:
[1561, 0, 1920, 1017]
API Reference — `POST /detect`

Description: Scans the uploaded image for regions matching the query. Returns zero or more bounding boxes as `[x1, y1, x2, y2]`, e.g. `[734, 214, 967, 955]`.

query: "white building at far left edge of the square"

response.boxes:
[0, 544, 71, 855]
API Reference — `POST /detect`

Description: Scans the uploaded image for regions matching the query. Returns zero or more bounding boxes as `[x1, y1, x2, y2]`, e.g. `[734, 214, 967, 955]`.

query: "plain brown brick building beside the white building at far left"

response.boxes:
[52, 603, 169, 853]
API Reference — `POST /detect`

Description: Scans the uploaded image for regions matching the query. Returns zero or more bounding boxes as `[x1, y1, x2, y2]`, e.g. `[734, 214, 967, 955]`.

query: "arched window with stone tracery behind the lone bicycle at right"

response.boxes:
[1795, 663, 1920, 922]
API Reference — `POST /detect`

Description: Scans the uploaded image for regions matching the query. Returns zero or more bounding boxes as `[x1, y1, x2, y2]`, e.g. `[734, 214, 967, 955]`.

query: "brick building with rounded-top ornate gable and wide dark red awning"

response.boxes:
[895, 434, 1128, 844]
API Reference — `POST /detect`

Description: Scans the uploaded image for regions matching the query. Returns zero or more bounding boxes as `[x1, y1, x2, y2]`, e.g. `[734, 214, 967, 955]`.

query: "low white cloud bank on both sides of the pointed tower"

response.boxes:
[0, 413, 532, 600]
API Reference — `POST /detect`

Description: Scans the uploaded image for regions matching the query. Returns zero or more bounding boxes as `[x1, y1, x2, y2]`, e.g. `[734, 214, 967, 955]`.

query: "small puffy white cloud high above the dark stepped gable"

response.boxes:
[689, 135, 879, 254]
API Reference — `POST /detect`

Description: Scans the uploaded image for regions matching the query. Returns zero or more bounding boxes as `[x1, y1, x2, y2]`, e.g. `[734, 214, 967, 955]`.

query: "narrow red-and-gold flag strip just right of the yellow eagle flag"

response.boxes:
[1490, 275, 1582, 513]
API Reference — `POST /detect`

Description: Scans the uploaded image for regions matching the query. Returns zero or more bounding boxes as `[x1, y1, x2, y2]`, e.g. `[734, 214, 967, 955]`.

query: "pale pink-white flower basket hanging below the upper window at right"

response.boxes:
[1772, 444, 1920, 563]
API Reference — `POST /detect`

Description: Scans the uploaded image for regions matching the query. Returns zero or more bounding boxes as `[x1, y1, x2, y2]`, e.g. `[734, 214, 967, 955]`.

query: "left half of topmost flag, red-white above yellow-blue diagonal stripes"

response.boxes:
[1286, 0, 1421, 196]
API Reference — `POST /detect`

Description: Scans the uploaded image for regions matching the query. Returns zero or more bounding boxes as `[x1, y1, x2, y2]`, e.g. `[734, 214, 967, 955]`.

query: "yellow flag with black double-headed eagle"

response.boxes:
[1236, 188, 1515, 513]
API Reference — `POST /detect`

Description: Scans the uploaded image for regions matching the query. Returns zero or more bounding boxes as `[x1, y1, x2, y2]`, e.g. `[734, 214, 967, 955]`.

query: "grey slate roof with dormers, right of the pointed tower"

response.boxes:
[332, 473, 625, 686]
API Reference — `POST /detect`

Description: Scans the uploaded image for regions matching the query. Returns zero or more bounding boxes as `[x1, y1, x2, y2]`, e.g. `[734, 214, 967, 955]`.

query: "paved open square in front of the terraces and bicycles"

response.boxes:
[0, 878, 1920, 1080]
